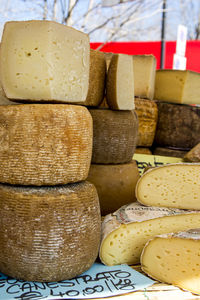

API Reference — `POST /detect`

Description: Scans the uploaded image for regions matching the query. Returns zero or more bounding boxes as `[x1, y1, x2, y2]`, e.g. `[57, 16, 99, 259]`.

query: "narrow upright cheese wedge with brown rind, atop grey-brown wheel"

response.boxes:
[106, 54, 135, 110]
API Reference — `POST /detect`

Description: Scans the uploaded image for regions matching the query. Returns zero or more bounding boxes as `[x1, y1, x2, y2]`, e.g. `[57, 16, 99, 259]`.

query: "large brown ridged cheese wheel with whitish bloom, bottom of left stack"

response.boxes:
[0, 182, 101, 282]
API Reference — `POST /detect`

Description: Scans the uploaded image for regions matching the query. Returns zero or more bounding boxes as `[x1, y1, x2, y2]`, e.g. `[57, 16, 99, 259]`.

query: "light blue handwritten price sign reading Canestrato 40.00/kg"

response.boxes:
[0, 263, 154, 300]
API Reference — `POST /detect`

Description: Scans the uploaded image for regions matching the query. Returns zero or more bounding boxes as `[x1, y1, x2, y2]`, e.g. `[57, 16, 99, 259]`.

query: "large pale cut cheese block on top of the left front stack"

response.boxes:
[0, 20, 90, 103]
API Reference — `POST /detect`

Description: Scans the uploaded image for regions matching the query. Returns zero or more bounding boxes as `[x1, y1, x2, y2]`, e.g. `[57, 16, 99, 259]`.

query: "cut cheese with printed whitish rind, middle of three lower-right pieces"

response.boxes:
[99, 202, 200, 265]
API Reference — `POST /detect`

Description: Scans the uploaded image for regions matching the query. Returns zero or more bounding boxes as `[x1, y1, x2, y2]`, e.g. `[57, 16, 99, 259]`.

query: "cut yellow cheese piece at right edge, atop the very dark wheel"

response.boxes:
[154, 70, 200, 104]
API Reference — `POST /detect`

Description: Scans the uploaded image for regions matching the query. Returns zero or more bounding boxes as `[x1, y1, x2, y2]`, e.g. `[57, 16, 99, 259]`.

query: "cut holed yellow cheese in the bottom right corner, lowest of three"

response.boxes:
[141, 229, 200, 294]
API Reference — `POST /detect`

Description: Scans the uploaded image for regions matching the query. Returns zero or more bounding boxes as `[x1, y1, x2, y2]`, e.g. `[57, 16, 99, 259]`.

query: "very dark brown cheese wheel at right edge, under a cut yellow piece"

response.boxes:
[155, 101, 200, 150]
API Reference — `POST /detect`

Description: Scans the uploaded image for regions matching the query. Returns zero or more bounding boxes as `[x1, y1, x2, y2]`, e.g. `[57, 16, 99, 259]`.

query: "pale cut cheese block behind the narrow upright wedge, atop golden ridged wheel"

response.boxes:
[132, 55, 156, 100]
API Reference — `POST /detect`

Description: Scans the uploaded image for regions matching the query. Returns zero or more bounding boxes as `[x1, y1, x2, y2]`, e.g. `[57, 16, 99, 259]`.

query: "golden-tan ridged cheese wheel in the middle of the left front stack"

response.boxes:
[0, 104, 92, 185]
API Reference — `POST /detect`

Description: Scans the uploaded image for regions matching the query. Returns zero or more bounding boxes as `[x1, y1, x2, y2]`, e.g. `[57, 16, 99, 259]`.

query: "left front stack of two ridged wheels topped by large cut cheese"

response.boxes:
[0, 21, 101, 282]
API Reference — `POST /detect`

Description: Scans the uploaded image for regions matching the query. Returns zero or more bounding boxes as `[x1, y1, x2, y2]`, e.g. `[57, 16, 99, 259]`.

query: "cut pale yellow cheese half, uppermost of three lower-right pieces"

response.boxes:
[136, 163, 200, 210]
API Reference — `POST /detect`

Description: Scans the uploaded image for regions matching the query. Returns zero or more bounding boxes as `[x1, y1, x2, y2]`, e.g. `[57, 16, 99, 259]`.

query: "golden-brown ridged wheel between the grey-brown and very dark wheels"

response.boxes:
[135, 98, 158, 147]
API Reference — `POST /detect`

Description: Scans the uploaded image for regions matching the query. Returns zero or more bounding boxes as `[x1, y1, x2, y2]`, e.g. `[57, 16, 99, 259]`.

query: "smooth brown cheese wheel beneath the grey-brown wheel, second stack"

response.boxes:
[87, 160, 140, 216]
